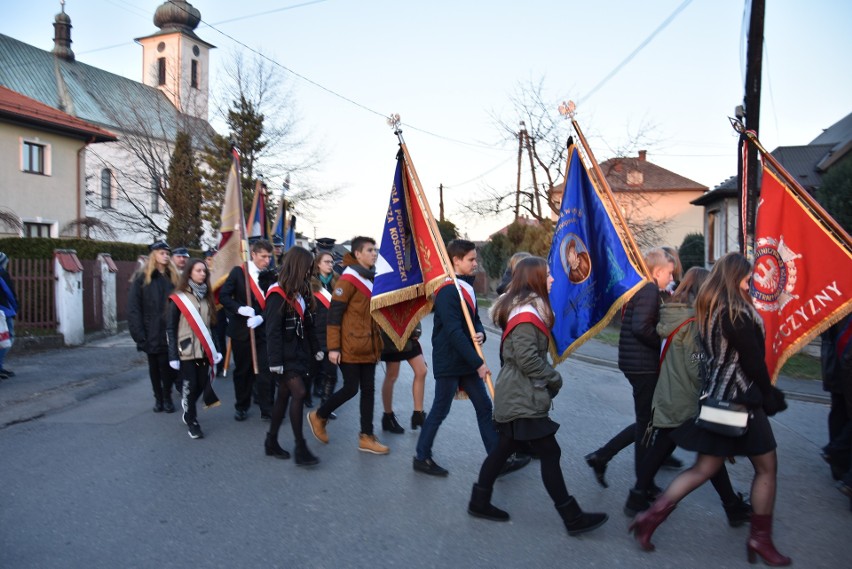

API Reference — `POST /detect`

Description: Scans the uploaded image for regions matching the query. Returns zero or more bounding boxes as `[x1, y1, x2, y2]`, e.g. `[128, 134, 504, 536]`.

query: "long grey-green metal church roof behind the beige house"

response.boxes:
[0, 34, 213, 142]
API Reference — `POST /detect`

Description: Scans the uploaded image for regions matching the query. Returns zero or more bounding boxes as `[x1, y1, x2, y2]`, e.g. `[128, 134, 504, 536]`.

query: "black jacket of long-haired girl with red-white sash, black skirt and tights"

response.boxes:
[263, 294, 320, 377]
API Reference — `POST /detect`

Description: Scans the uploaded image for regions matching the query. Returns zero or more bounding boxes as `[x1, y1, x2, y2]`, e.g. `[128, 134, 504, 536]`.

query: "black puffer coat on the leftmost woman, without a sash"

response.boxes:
[127, 271, 174, 354]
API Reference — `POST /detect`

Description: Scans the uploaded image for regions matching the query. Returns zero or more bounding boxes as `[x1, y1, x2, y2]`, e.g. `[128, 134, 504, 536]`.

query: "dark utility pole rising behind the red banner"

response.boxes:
[739, 0, 766, 255]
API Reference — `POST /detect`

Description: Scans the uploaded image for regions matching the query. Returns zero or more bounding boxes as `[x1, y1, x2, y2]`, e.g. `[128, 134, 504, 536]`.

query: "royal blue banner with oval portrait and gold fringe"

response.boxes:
[548, 140, 648, 362]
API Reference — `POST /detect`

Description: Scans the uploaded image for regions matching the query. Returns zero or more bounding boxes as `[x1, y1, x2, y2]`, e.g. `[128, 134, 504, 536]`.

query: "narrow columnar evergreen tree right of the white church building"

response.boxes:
[165, 132, 204, 249]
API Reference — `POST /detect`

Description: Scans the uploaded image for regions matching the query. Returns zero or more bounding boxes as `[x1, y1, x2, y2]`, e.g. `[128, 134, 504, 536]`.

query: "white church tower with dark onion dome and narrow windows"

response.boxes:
[136, 0, 216, 121]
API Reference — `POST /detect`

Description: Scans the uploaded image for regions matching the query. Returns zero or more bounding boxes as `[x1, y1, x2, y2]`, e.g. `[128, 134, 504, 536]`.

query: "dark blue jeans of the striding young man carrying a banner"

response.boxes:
[417, 373, 499, 460]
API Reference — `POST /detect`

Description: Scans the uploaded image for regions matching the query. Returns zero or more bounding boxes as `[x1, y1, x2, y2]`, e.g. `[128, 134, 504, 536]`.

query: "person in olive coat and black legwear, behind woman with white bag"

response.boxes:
[624, 267, 751, 527]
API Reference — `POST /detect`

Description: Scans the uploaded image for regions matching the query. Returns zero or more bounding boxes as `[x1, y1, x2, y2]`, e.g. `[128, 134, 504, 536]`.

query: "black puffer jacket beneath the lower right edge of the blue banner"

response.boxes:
[618, 283, 662, 375]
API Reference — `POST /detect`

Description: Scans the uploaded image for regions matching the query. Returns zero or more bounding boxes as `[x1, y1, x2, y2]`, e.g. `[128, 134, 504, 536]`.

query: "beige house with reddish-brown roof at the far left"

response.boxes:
[0, 87, 116, 237]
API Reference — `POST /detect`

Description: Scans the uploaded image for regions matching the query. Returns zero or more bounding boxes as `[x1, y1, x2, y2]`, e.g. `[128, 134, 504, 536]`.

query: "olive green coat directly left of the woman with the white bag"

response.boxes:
[651, 303, 704, 429]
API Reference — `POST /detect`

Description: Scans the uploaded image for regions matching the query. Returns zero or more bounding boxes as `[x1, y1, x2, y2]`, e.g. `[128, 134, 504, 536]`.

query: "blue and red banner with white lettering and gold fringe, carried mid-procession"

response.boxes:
[370, 151, 447, 349]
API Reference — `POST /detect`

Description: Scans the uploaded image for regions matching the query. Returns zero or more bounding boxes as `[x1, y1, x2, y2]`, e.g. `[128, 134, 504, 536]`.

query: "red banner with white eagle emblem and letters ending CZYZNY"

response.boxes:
[751, 165, 852, 381]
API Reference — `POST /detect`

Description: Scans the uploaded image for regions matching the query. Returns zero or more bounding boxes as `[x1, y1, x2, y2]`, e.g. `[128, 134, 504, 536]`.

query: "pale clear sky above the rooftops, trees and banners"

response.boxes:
[0, 0, 852, 245]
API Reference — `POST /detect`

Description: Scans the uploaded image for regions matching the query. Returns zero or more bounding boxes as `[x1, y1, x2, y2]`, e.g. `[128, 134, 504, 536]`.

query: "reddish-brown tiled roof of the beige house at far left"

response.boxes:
[0, 87, 116, 142]
